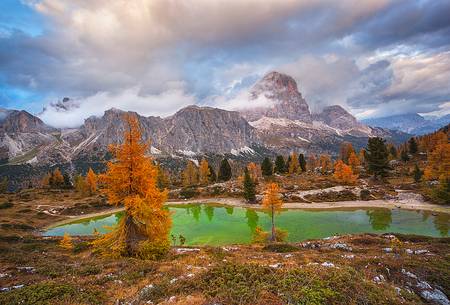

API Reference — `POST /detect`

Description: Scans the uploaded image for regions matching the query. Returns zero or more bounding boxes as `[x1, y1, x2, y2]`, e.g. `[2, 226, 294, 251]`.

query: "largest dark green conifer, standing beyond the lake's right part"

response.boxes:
[366, 137, 389, 179]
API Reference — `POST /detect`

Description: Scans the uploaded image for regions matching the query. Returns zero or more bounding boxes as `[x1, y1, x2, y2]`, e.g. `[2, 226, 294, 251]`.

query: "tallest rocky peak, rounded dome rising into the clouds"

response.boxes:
[241, 72, 312, 123]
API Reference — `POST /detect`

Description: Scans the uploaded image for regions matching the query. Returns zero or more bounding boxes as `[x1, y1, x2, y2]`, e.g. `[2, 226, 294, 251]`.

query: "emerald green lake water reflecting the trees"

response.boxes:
[44, 204, 450, 245]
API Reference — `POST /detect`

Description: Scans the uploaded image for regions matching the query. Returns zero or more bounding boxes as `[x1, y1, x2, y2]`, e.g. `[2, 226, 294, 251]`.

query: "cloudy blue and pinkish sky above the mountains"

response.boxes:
[0, 0, 450, 127]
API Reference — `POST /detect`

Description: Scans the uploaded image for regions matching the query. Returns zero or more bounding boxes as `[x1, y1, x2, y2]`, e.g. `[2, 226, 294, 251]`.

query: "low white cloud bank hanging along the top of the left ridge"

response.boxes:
[39, 87, 196, 128]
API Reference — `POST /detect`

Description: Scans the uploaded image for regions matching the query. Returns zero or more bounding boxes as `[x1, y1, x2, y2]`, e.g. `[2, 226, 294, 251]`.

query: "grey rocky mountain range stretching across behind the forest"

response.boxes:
[0, 72, 409, 166]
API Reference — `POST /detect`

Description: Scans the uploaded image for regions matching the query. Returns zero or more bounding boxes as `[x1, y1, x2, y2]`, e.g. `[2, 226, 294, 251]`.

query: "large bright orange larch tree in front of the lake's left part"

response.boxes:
[94, 114, 172, 259]
